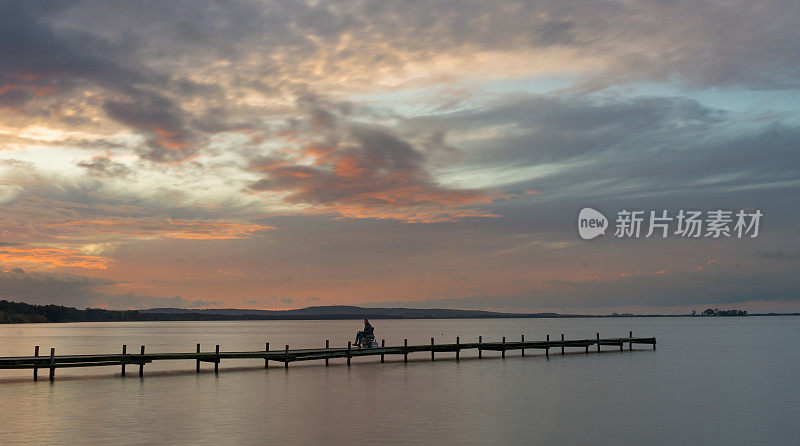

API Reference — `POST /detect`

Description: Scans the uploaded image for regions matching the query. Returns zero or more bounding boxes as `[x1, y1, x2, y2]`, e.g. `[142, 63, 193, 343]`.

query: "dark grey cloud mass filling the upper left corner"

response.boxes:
[0, 2, 225, 162]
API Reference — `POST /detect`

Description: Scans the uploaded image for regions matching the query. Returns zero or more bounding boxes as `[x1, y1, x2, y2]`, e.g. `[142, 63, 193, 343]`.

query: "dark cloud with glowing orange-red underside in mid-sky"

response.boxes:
[250, 107, 493, 222]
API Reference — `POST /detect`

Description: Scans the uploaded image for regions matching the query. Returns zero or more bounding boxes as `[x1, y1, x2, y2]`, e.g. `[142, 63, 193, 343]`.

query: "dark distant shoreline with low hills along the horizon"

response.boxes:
[0, 300, 800, 324]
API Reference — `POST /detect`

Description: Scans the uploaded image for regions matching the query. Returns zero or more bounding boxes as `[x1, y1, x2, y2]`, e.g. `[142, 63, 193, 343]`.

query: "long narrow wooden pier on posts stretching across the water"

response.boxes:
[0, 332, 656, 381]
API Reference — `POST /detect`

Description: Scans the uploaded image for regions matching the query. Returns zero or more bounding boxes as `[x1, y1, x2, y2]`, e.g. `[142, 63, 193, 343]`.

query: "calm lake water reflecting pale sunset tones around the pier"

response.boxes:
[0, 317, 800, 445]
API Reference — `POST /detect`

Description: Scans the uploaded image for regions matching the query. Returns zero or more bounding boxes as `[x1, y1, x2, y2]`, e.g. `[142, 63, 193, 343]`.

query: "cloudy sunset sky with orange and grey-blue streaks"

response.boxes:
[0, 0, 800, 313]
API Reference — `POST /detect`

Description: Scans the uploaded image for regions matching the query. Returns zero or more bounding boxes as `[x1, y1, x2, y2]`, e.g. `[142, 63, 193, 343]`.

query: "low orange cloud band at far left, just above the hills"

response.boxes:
[0, 247, 113, 270]
